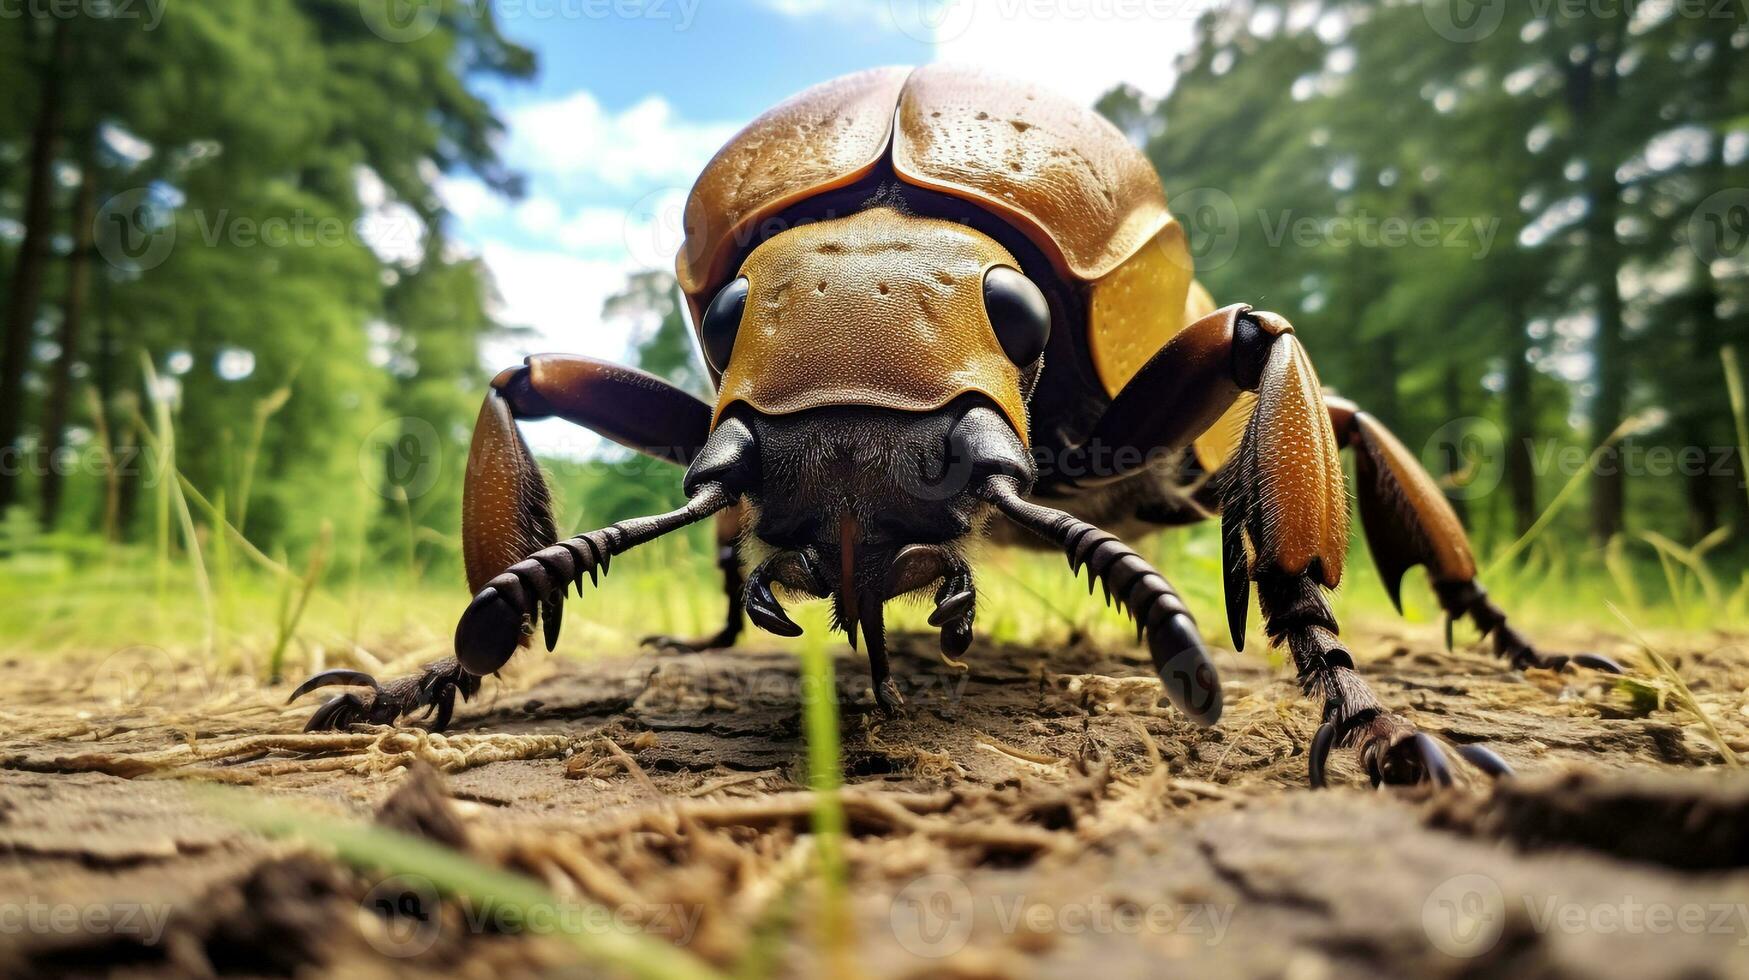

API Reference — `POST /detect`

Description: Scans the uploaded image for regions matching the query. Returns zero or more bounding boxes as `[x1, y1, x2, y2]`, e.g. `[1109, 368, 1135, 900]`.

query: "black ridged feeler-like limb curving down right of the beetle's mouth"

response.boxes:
[979, 476, 1221, 725]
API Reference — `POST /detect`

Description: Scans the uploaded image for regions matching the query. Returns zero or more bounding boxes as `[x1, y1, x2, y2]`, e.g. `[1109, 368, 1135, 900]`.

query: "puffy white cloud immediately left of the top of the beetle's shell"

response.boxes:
[509, 91, 740, 189]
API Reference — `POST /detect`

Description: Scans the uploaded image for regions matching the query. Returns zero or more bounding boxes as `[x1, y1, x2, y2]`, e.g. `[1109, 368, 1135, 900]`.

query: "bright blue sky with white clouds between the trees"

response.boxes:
[442, 0, 1214, 455]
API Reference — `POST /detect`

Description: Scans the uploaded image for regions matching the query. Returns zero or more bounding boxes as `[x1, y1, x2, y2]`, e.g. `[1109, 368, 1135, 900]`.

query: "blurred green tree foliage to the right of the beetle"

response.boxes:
[1140, 0, 1749, 553]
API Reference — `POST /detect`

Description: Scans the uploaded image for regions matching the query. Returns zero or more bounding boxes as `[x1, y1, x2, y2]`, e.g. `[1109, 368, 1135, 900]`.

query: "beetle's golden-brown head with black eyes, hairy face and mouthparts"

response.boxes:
[687, 207, 1051, 637]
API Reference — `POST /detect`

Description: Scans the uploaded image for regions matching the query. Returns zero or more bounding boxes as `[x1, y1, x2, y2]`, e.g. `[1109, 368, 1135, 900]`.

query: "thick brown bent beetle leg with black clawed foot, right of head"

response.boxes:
[1063, 305, 1504, 786]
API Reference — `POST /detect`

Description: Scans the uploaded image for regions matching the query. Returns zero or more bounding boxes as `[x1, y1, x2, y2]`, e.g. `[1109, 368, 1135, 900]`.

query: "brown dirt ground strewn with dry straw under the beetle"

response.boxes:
[0, 627, 1749, 980]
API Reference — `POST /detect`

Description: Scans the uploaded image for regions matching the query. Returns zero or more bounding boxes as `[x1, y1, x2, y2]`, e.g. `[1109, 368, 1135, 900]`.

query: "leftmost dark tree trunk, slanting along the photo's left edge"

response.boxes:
[0, 18, 72, 511]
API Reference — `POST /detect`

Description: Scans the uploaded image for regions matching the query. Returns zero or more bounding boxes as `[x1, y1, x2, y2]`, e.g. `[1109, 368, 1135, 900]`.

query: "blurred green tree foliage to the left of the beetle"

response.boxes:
[0, 0, 533, 562]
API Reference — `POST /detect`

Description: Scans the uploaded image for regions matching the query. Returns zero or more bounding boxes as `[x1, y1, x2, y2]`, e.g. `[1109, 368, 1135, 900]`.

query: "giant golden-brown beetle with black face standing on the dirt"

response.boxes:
[292, 65, 1620, 786]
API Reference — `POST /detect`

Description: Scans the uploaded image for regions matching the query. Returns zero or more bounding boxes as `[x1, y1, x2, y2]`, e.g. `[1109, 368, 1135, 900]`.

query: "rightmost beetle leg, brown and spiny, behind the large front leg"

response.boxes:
[1324, 397, 1621, 674]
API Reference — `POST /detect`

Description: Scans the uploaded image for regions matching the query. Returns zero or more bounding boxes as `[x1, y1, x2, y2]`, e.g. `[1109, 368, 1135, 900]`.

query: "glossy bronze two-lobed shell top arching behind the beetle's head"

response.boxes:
[677, 65, 1172, 302]
